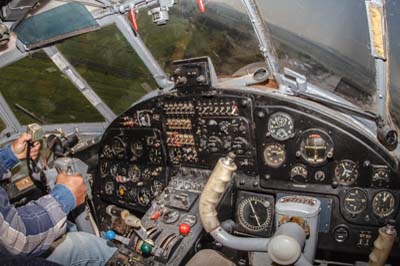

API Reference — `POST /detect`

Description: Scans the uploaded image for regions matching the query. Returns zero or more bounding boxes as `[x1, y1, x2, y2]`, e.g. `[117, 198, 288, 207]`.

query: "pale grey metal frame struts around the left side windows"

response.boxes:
[0, 1, 173, 139]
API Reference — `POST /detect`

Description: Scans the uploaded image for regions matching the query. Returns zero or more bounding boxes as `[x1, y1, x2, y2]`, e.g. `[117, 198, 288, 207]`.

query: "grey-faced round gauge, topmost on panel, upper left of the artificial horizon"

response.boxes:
[268, 112, 294, 141]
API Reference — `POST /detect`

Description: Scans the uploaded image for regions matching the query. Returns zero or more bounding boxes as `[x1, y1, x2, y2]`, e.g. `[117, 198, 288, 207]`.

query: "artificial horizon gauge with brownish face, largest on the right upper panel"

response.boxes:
[299, 129, 333, 165]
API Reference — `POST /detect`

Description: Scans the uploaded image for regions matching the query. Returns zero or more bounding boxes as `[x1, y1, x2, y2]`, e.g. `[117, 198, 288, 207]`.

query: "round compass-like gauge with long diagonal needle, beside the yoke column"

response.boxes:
[238, 196, 272, 232]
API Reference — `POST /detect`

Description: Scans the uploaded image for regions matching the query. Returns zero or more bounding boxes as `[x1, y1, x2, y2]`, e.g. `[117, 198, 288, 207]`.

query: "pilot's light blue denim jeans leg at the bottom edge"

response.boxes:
[46, 232, 117, 266]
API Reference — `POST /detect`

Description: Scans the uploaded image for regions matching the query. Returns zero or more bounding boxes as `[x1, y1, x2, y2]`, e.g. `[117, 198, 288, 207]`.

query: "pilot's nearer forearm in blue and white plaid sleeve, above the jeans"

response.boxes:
[0, 185, 75, 255]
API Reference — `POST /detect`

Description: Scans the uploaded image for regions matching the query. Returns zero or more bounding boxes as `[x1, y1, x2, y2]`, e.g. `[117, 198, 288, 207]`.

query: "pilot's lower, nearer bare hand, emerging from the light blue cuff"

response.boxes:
[56, 172, 86, 207]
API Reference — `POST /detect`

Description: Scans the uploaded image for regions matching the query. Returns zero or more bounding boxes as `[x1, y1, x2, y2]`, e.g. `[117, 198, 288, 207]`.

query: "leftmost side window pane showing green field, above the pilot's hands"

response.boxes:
[0, 51, 104, 124]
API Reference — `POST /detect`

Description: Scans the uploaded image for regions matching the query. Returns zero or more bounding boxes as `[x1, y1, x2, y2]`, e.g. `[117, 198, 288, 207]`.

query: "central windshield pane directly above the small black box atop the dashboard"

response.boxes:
[138, 0, 263, 76]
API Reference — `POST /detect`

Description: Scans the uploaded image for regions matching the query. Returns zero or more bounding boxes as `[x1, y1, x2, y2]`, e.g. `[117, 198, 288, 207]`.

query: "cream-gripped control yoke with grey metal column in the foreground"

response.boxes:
[199, 153, 321, 266]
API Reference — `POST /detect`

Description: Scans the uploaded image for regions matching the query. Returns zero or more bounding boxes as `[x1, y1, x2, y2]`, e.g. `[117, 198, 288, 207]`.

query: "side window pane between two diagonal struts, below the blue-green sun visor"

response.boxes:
[57, 25, 157, 114]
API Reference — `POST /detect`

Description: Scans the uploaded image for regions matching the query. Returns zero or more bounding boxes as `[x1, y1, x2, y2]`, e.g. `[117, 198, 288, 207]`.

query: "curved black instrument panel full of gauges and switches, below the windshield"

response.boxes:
[95, 89, 400, 258]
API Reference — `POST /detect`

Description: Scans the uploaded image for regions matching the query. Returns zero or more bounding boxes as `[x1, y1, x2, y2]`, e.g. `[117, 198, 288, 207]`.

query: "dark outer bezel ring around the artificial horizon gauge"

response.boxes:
[296, 128, 335, 166]
